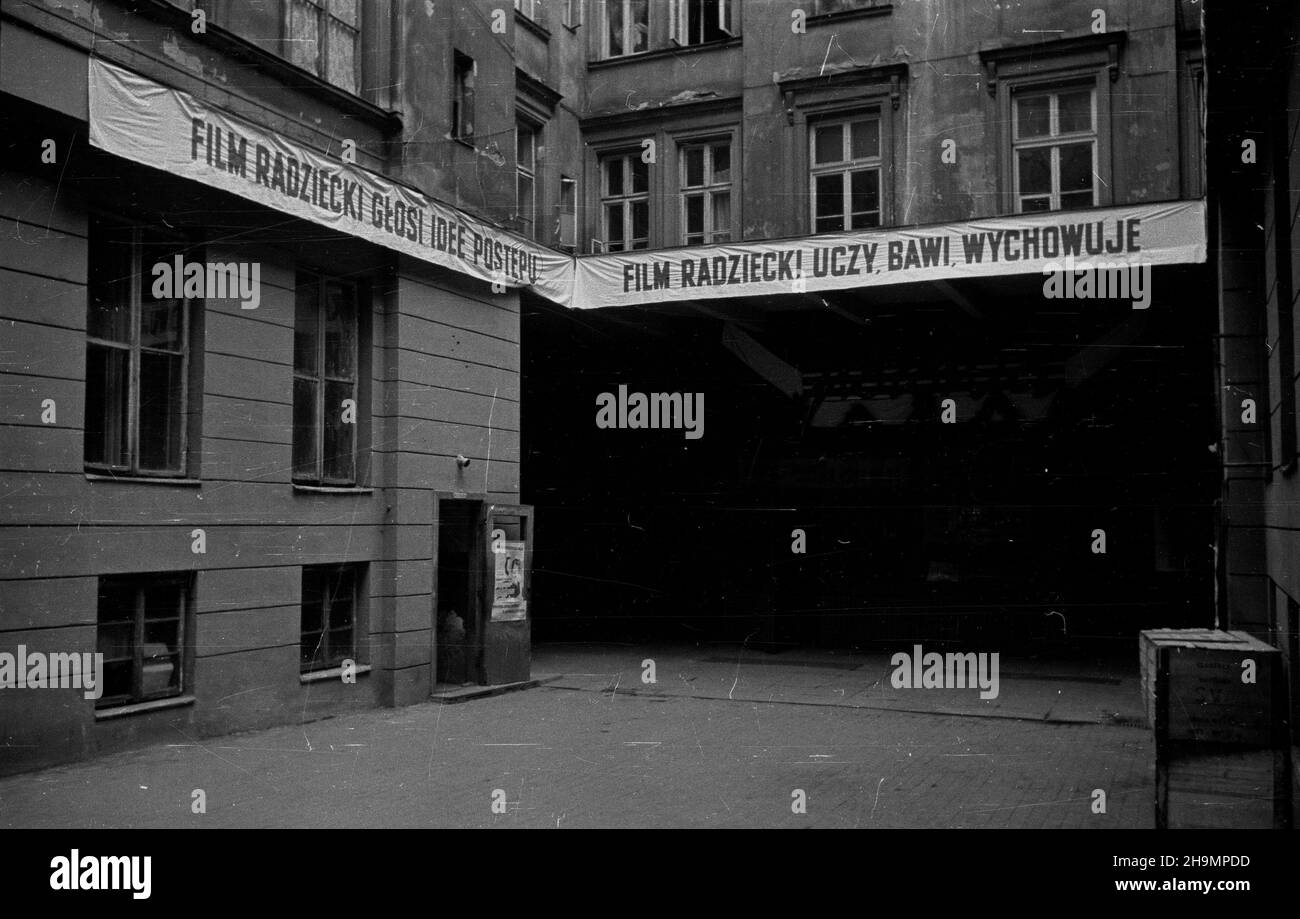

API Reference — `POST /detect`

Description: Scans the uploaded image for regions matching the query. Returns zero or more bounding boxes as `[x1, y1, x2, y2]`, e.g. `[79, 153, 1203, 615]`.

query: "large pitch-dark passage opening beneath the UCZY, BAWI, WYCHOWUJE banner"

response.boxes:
[523, 268, 1218, 654]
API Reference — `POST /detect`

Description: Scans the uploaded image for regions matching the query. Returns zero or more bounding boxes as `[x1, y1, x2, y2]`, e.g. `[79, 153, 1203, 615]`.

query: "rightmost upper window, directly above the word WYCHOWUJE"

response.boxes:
[1011, 86, 1097, 212]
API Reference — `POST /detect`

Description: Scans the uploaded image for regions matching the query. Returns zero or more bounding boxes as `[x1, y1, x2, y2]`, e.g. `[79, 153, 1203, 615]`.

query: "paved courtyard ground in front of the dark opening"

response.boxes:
[0, 647, 1153, 828]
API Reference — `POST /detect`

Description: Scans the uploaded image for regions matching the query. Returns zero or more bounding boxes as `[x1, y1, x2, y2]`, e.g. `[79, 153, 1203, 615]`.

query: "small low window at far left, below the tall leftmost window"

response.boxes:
[96, 575, 191, 708]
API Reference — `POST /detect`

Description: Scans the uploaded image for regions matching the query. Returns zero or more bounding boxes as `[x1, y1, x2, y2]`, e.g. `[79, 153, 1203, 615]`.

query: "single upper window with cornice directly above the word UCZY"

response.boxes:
[809, 114, 880, 233]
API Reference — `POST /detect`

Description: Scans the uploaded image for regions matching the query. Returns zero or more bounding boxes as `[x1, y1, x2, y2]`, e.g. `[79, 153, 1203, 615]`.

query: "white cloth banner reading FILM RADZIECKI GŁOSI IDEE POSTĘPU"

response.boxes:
[90, 57, 573, 303]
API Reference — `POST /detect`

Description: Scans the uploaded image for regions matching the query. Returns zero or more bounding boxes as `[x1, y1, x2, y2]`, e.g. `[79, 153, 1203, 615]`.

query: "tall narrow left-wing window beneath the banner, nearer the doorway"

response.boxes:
[294, 274, 360, 485]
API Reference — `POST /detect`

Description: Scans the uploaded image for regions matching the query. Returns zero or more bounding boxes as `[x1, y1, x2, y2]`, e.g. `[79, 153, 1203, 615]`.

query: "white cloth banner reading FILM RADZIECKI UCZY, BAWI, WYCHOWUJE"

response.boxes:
[568, 200, 1205, 308]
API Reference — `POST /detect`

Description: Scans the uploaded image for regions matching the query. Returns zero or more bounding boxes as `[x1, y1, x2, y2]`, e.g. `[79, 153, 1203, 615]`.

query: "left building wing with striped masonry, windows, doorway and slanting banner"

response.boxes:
[0, 0, 554, 771]
